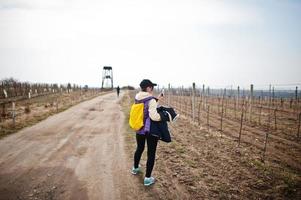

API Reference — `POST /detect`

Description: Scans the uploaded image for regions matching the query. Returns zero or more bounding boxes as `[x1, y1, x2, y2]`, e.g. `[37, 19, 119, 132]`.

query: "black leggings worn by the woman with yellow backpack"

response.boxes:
[134, 134, 158, 177]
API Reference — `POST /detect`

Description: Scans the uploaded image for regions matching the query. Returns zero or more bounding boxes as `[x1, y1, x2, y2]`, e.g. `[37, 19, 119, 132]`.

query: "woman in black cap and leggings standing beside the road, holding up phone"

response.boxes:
[132, 79, 163, 186]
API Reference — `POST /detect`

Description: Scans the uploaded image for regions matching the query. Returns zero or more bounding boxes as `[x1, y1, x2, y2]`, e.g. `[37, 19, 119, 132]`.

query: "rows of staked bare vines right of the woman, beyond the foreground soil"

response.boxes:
[165, 84, 301, 163]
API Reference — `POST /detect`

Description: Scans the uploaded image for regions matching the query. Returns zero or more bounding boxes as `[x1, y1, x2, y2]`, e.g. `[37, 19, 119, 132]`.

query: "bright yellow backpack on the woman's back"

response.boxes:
[129, 97, 153, 131]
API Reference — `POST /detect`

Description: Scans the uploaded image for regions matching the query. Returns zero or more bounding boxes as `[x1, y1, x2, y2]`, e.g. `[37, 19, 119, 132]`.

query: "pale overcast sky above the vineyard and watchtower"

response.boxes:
[0, 0, 301, 87]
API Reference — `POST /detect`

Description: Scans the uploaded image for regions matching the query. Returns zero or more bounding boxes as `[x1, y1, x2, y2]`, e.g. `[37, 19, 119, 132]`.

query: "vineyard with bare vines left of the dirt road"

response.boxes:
[0, 78, 101, 136]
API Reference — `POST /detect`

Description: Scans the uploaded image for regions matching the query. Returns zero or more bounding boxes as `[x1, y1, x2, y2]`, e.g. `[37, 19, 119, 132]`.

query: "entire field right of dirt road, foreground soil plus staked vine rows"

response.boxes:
[120, 87, 301, 199]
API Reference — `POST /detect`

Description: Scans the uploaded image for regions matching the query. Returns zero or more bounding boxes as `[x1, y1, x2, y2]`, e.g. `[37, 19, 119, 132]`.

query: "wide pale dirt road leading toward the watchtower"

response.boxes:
[0, 93, 139, 199]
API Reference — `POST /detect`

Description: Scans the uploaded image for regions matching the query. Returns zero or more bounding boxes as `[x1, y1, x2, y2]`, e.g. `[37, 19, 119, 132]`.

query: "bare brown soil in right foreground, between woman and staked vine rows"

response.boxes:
[120, 93, 301, 199]
